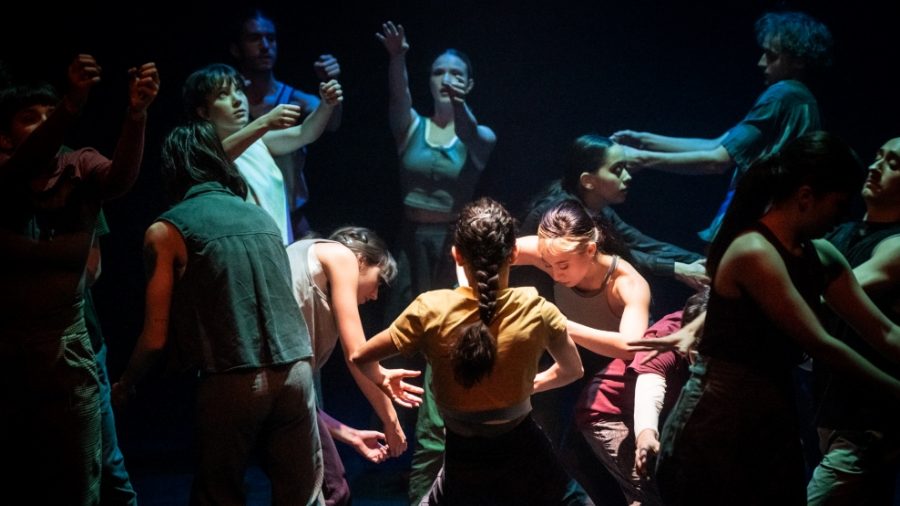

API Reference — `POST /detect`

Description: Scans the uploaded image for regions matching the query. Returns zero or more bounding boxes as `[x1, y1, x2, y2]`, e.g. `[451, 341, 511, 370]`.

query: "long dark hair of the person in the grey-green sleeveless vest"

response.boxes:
[160, 121, 247, 201]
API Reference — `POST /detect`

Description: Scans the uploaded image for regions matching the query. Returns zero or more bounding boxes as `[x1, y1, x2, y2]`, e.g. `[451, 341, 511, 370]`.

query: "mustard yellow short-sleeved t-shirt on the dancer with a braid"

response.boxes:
[390, 287, 566, 412]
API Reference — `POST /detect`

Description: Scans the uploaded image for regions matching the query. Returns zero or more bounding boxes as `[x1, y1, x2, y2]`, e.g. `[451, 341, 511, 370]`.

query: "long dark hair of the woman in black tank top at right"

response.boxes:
[706, 131, 864, 278]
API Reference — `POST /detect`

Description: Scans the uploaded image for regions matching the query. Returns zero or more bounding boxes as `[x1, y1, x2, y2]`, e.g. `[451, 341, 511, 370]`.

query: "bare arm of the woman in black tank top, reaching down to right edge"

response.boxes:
[728, 233, 900, 396]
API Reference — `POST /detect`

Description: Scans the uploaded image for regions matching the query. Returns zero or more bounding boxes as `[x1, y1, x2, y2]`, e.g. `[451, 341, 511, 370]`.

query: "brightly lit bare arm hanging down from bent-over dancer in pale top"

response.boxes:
[314, 243, 406, 457]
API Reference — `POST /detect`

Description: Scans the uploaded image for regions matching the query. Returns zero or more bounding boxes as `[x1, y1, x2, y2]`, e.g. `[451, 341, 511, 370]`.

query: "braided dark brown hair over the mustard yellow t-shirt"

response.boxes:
[451, 197, 516, 388]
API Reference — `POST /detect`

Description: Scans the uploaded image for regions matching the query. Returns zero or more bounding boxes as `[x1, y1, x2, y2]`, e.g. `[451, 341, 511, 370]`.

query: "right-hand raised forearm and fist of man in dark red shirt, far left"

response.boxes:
[101, 63, 159, 198]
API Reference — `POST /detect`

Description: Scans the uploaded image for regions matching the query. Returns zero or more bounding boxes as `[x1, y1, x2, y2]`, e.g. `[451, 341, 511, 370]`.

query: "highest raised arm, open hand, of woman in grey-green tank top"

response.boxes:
[375, 21, 416, 146]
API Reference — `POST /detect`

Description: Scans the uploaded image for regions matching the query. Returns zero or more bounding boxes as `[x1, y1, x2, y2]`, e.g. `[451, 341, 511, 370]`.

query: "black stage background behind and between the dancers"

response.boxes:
[0, 0, 900, 498]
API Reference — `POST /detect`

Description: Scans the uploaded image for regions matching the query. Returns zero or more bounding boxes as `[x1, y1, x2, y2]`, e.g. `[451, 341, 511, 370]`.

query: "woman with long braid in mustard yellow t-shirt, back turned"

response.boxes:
[351, 198, 582, 505]
